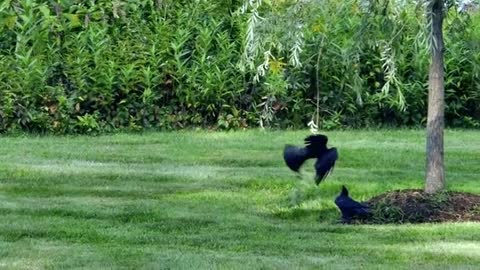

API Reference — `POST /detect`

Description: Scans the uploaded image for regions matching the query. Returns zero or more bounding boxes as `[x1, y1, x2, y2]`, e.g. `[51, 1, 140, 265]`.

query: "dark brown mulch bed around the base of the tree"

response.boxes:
[360, 189, 480, 224]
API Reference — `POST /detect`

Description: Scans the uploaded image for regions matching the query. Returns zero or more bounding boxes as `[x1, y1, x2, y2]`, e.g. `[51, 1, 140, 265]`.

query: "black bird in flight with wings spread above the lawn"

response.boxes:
[283, 134, 338, 185]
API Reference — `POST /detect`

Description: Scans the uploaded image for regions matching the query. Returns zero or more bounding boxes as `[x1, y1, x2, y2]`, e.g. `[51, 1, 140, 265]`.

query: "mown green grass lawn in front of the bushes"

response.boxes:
[0, 130, 480, 269]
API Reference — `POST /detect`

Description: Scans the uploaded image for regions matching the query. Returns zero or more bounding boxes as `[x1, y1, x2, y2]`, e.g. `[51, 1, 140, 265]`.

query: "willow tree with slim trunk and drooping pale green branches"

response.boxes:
[241, 0, 446, 193]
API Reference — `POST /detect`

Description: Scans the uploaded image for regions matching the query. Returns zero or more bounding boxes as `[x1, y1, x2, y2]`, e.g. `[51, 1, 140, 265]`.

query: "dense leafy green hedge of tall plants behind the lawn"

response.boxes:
[0, 0, 480, 133]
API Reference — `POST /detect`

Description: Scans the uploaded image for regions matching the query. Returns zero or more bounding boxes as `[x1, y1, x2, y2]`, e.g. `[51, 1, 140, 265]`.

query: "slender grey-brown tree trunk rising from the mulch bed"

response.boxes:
[425, 0, 445, 193]
